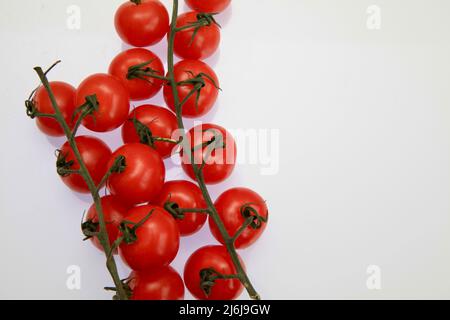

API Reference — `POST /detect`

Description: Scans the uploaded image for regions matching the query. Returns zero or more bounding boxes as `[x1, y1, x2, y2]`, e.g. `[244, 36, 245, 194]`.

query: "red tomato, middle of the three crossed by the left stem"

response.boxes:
[60, 136, 111, 193]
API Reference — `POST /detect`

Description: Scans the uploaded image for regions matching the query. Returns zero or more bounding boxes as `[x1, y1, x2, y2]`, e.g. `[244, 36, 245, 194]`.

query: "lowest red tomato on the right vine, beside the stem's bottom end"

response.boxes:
[184, 246, 243, 300]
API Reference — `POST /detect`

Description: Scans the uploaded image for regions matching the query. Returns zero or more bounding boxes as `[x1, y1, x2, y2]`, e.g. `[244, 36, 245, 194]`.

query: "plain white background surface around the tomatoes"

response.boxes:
[0, 0, 450, 299]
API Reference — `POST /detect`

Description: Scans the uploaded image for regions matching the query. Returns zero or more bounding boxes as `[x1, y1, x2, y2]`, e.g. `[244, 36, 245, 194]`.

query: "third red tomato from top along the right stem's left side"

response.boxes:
[122, 104, 178, 158]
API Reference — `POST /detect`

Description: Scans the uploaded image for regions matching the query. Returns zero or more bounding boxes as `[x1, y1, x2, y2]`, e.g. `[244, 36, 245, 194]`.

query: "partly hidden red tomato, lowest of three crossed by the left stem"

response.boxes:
[86, 196, 128, 251]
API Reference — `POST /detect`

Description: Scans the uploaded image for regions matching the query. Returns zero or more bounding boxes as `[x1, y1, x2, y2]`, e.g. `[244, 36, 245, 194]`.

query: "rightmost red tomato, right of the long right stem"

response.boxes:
[209, 188, 269, 249]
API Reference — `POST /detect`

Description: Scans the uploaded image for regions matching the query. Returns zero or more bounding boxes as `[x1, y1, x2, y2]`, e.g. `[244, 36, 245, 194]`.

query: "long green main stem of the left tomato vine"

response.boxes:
[34, 67, 128, 300]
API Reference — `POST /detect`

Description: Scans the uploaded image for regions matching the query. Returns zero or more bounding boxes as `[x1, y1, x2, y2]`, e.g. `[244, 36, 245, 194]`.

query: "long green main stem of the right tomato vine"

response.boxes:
[167, 0, 261, 300]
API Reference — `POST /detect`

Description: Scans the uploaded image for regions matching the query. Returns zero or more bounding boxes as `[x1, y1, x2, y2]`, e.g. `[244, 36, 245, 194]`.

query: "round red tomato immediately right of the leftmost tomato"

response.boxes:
[76, 73, 130, 132]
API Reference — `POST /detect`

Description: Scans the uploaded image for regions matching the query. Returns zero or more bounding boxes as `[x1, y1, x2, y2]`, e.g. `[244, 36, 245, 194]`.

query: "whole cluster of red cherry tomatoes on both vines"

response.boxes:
[29, 0, 268, 300]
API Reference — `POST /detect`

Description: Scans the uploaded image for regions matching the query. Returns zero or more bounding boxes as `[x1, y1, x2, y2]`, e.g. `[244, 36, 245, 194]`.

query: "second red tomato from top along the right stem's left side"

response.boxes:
[109, 48, 165, 100]
